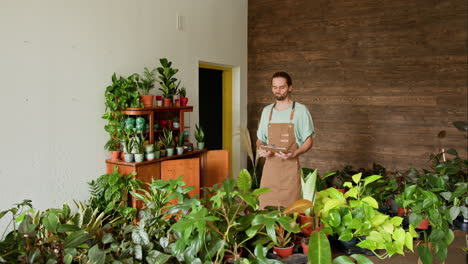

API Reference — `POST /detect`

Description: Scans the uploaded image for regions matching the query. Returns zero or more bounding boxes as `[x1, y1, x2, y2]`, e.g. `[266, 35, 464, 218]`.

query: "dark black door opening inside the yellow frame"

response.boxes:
[198, 68, 223, 150]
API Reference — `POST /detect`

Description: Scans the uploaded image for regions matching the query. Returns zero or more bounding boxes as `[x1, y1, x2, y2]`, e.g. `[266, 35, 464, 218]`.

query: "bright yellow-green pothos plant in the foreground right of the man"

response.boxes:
[314, 173, 416, 259]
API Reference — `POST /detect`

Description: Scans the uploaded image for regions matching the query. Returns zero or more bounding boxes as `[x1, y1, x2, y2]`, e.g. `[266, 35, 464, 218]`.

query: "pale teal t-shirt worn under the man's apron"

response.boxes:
[257, 102, 315, 147]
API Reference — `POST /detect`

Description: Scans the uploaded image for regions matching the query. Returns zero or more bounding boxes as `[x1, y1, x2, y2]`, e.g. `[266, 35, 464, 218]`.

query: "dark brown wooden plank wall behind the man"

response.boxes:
[248, 0, 467, 173]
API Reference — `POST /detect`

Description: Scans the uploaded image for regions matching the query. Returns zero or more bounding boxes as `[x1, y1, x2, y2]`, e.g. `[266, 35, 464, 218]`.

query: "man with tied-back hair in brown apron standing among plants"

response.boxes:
[257, 72, 315, 208]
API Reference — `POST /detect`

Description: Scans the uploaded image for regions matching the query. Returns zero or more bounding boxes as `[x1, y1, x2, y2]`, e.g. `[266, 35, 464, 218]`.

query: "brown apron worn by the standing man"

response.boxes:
[259, 102, 301, 208]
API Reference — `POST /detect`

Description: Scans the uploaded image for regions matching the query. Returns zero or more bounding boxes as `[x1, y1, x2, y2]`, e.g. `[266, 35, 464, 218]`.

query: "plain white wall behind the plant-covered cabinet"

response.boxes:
[0, 0, 247, 227]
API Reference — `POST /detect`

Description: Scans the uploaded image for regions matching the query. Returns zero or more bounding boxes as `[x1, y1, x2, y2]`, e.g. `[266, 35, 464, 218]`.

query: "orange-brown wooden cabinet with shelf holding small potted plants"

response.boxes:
[106, 106, 229, 208]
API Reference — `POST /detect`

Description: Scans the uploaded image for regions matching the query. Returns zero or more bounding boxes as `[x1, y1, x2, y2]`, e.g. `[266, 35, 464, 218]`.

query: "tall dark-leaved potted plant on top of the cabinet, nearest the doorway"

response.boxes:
[157, 58, 180, 107]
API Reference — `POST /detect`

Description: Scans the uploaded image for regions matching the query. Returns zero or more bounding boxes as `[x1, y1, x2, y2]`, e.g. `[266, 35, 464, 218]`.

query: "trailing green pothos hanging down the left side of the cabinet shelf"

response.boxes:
[102, 73, 143, 151]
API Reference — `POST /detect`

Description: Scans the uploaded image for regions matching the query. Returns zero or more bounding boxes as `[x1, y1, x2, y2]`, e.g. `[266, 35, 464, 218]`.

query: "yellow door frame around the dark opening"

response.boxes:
[198, 64, 232, 177]
